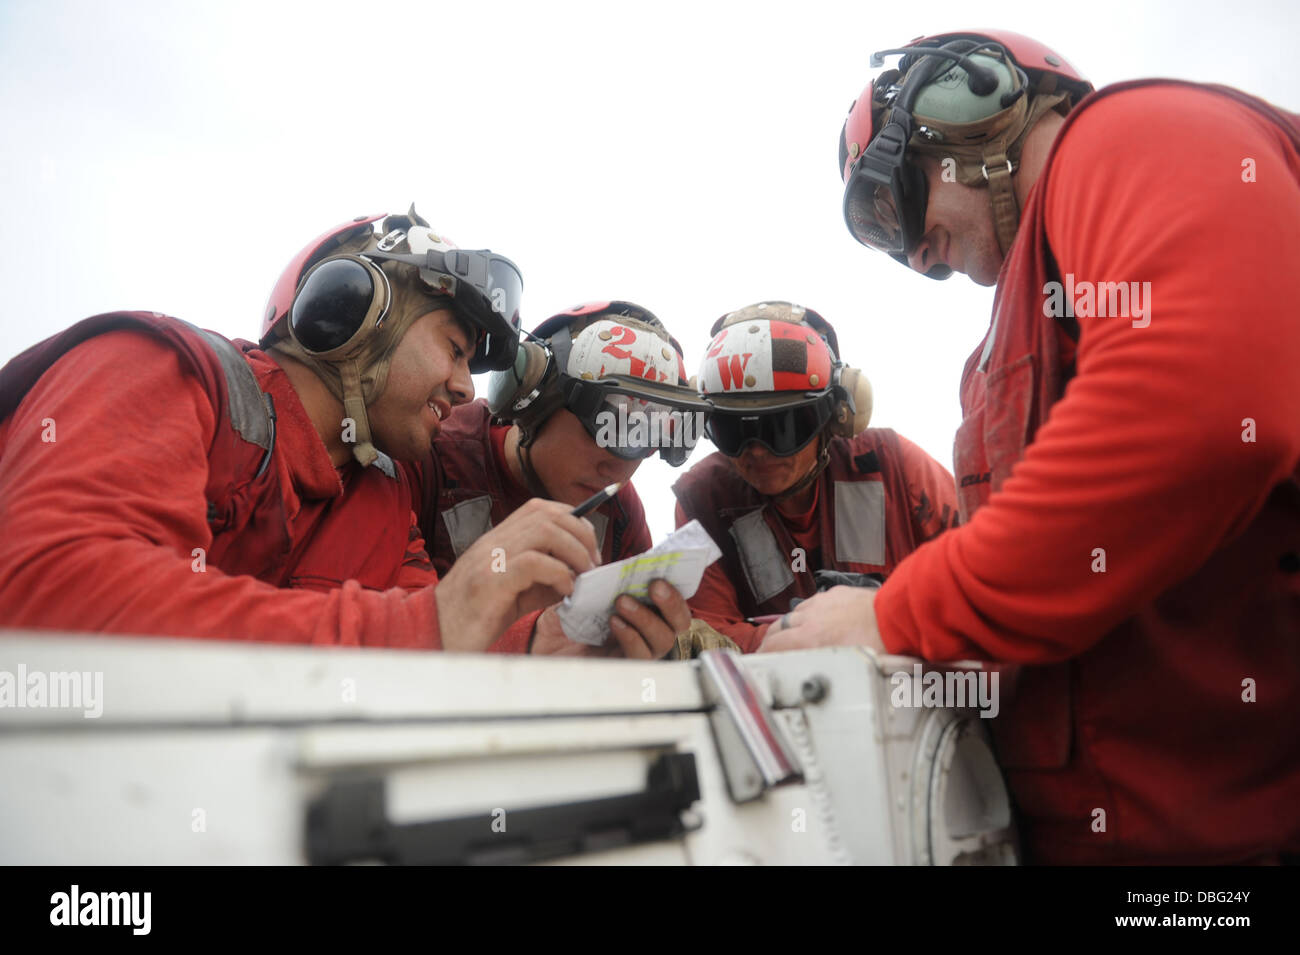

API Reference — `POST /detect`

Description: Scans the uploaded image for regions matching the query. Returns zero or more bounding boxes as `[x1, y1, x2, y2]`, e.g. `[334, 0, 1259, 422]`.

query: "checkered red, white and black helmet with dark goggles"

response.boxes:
[697, 301, 871, 462]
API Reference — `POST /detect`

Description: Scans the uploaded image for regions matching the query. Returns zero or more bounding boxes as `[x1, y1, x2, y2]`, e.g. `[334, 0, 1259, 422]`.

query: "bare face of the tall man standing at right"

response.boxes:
[907, 156, 1002, 286]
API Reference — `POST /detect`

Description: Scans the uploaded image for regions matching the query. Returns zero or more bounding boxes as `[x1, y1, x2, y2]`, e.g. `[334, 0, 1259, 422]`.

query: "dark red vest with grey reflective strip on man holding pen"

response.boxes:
[0, 312, 411, 590]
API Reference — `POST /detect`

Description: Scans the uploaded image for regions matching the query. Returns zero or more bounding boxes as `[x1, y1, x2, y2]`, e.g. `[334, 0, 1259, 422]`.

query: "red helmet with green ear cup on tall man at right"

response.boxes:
[839, 30, 1092, 278]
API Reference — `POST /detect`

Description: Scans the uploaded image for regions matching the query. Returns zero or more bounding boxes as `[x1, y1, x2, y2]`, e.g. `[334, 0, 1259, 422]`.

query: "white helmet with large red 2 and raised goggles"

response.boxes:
[488, 301, 703, 472]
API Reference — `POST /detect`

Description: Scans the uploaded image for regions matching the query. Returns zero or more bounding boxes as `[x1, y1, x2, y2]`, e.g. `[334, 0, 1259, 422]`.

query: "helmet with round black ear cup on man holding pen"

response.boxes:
[260, 205, 524, 466]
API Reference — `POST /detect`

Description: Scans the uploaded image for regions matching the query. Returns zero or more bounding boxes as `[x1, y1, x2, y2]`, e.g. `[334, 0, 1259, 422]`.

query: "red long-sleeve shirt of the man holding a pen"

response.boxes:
[0, 331, 537, 652]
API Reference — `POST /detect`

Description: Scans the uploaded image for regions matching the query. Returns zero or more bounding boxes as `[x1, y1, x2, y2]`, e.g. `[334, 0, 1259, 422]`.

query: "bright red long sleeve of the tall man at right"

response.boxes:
[875, 87, 1300, 663]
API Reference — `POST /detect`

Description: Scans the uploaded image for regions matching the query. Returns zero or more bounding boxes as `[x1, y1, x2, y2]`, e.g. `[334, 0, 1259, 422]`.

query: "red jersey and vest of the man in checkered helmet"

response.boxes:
[673, 427, 957, 652]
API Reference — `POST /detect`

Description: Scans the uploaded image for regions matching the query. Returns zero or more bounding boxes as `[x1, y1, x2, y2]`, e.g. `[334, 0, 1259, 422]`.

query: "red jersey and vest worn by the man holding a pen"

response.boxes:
[0, 313, 536, 652]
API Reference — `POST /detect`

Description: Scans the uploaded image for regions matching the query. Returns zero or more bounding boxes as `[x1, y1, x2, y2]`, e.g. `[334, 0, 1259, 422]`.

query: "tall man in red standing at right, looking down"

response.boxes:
[764, 32, 1300, 863]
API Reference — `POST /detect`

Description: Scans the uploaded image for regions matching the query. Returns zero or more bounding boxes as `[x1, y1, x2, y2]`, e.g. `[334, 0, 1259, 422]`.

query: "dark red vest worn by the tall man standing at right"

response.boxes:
[954, 81, 1300, 863]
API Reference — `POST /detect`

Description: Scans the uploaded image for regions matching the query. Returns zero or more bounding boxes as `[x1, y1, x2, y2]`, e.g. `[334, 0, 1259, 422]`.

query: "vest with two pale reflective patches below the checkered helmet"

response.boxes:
[672, 427, 930, 617]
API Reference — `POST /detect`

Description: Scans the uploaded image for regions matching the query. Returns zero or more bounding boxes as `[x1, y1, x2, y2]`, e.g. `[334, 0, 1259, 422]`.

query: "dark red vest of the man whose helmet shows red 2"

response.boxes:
[408, 399, 629, 574]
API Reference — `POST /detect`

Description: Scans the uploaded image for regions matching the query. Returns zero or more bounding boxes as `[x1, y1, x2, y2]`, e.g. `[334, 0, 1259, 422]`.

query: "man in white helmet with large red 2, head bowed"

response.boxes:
[406, 301, 697, 654]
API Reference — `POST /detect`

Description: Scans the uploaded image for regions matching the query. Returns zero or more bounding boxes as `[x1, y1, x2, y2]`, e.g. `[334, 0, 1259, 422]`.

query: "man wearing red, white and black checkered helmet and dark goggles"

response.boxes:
[673, 301, 957, 651]
